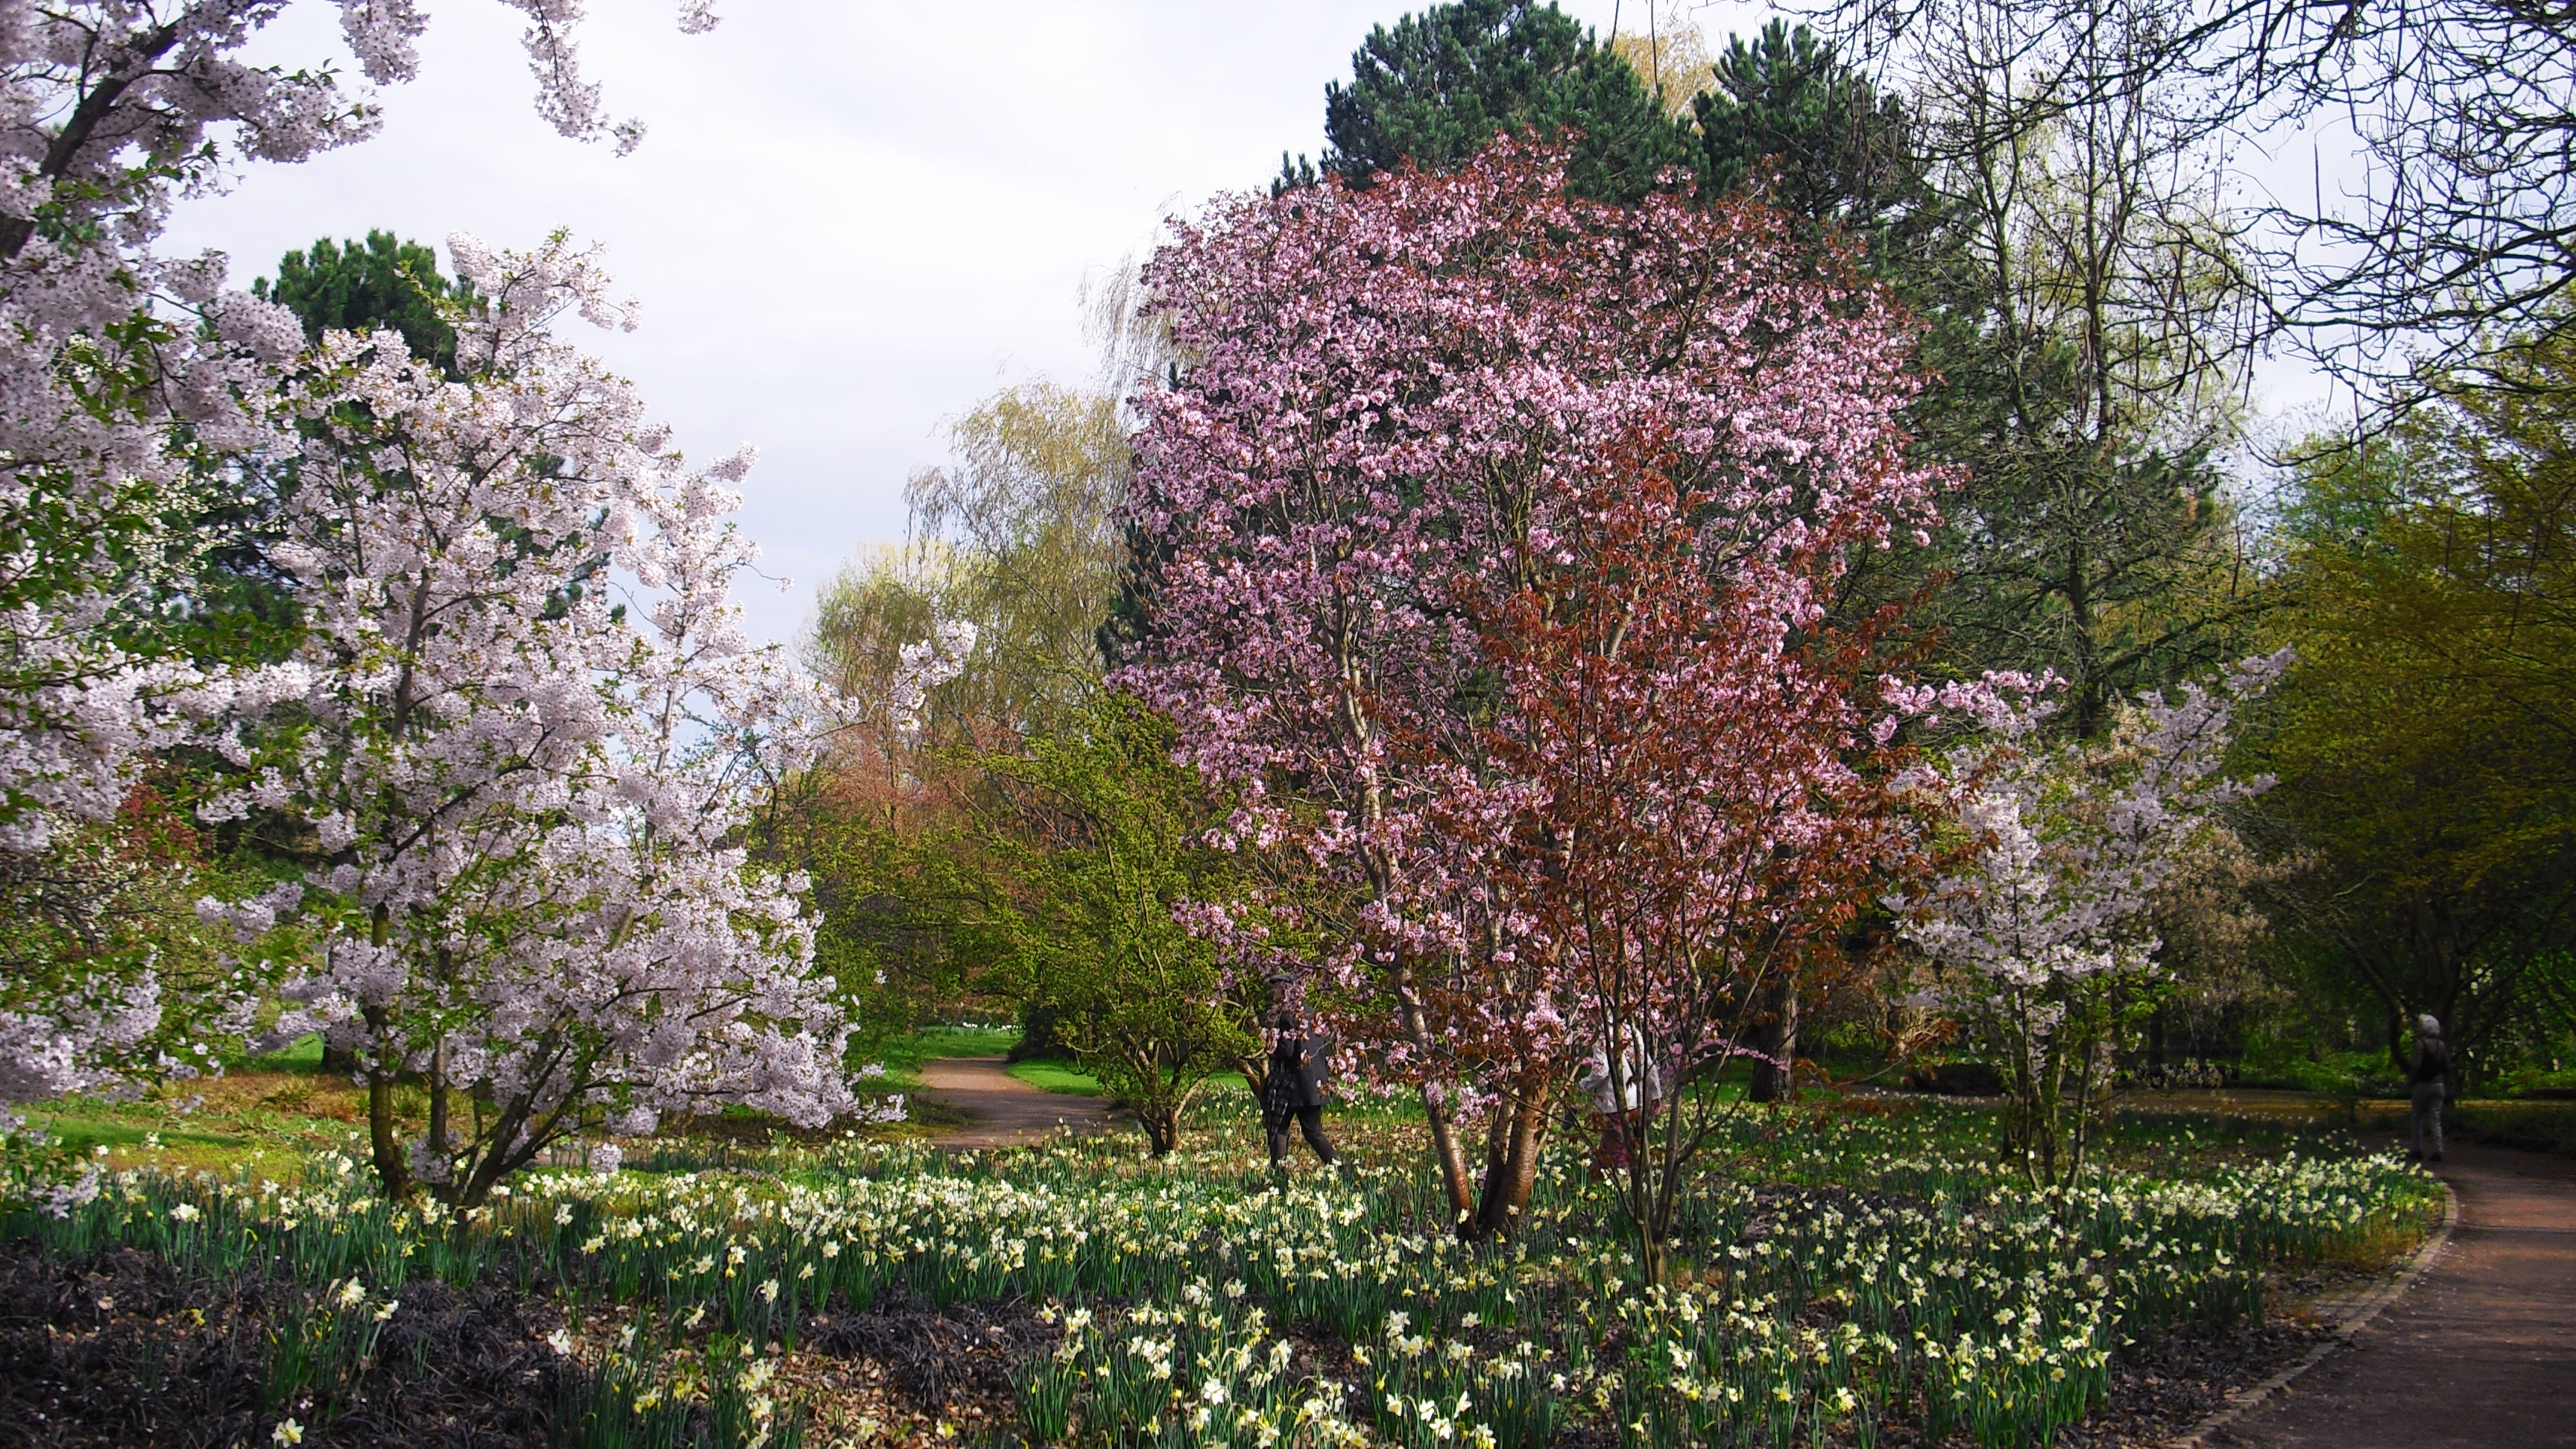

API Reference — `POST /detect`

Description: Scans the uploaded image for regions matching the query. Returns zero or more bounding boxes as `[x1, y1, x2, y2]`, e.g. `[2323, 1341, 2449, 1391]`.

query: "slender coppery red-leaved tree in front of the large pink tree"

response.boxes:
[1458, 433, 1981, 1281]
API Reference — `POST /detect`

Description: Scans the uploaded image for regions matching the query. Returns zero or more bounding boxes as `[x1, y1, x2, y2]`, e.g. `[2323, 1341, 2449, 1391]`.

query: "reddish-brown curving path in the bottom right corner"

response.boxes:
[2210, 1145, 2576, 1449]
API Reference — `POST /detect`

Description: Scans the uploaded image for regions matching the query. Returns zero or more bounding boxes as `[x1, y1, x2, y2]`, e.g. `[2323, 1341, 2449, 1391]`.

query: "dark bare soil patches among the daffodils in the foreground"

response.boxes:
[0, 1227, 2370, 1449]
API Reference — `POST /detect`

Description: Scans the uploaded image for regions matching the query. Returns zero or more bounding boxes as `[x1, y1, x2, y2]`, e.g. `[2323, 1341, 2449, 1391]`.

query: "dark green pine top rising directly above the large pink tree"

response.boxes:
[1308, 0, 1690, 201]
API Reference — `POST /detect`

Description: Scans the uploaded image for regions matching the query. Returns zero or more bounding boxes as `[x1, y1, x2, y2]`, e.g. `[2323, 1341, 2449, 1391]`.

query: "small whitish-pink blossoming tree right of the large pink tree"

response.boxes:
[1891, 652, 2290, 1189]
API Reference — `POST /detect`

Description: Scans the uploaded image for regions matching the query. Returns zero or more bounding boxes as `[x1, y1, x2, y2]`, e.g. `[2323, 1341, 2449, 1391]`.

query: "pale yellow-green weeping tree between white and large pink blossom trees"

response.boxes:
[773, 382, 1128, 1029]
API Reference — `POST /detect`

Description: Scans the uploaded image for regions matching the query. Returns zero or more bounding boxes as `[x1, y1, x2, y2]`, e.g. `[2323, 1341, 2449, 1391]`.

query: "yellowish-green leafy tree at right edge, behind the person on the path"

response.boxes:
[2259, 332, 2576, 1080]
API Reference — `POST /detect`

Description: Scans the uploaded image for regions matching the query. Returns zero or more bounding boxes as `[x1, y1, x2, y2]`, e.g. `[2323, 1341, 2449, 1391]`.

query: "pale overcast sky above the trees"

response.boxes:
[170, 0, 2339, 640]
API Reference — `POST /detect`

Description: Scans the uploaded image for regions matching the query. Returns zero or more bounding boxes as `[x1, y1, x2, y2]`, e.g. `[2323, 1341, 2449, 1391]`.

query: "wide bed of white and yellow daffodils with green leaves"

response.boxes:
[18, 1108, 2440, 1449]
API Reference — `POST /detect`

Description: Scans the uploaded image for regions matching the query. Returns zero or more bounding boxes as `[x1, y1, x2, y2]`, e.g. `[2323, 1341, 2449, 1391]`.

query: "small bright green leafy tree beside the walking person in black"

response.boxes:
[984, 693, 1260, 1158]
